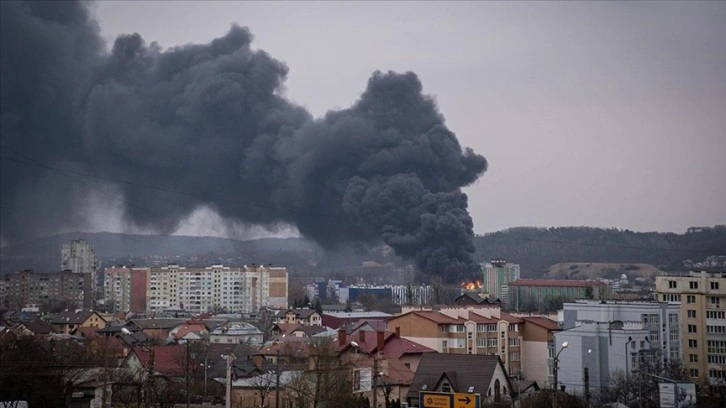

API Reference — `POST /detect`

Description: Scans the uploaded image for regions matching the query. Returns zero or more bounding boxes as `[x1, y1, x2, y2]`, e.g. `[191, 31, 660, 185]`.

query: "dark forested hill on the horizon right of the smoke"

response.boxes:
[474, 226, 726, 277]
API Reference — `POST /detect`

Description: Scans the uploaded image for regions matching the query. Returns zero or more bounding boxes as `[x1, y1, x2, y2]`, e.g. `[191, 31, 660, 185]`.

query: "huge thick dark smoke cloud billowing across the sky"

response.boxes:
[2, 2, 487, 281]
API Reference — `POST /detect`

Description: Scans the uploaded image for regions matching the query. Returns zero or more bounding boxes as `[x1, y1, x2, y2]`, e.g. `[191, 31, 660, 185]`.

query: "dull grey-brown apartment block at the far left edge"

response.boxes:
[0, 270, 91, 311]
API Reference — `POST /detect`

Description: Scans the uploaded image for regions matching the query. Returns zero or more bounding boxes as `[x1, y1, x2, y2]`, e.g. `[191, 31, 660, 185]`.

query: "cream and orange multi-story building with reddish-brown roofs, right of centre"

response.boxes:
[388, 306, 524, 375]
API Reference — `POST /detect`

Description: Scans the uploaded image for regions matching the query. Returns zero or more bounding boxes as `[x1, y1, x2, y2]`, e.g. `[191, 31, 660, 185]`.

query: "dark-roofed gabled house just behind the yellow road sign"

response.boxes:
[407, 353, 512, 407]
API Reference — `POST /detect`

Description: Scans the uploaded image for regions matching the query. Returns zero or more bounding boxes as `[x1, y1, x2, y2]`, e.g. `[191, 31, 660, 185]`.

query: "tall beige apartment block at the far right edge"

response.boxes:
[655, 271, 726, 394]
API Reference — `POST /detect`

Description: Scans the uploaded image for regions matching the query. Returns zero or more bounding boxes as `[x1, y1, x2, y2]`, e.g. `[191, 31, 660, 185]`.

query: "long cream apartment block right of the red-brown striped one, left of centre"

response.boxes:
[146, 265, 288, 314]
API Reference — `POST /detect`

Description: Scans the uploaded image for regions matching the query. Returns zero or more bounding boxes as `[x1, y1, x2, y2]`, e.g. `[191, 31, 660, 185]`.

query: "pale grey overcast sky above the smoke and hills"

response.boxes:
[93, 1, 726, 233]
